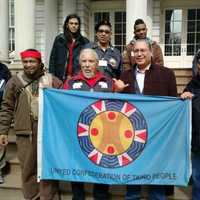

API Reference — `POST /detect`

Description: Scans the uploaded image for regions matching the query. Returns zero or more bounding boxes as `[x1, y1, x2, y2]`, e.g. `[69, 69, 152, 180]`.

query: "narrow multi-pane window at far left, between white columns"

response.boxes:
[8, 0, 15, 53]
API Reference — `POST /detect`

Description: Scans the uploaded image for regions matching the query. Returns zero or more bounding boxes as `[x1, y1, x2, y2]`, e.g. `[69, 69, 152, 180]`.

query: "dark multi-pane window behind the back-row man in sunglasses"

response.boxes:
[92, 11, 126, 52]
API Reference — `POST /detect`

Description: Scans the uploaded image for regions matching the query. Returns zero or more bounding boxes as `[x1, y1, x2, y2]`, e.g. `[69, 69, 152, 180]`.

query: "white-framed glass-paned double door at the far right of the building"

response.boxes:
[164, 8, 200, 68]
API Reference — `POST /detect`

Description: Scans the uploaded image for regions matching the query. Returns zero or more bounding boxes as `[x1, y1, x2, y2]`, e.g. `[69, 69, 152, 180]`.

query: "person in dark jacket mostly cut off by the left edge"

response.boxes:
[0, 61, 11, 183]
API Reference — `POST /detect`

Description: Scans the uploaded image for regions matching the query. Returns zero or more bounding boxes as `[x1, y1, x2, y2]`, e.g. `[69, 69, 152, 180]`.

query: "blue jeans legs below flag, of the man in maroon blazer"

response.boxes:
[125, 185, 166, 200]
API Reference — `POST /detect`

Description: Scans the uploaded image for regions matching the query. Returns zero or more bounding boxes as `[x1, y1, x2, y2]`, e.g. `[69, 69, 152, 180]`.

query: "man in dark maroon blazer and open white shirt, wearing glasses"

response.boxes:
[121, 39, 177, 200]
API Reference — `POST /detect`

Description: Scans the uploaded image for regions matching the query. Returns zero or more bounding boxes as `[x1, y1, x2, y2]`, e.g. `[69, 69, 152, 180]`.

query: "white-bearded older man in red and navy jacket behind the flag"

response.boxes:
[64, 49, 125, 200]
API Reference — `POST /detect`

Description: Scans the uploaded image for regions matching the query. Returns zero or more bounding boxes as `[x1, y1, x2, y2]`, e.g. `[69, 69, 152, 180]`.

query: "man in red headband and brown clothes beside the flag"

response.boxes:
[0, 49, 62, 200]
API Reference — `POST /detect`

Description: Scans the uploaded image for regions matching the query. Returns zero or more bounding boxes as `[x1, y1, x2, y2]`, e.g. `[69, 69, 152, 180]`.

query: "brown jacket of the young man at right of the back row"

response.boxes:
[122, 39, 164, 70]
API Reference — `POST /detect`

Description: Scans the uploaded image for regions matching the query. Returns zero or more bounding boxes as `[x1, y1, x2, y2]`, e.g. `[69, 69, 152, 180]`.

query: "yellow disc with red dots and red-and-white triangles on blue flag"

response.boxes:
[78, 100, 147, 166]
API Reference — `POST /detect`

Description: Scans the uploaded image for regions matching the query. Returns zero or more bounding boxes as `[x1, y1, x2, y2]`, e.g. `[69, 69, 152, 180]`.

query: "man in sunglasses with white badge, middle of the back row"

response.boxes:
[85, 20, 122, 78]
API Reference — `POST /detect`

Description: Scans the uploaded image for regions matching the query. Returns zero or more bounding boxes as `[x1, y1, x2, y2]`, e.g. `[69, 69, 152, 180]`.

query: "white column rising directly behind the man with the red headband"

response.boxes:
[15, 0, 35, 60]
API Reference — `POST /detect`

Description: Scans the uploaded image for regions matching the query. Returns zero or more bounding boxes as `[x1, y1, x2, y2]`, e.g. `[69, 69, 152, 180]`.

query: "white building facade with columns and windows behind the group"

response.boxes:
[0, 0, 200, 68]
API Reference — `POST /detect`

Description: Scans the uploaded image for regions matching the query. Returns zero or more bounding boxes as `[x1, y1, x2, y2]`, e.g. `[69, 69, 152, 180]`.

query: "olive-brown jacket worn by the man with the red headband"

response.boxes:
[0, 74, 62, 135]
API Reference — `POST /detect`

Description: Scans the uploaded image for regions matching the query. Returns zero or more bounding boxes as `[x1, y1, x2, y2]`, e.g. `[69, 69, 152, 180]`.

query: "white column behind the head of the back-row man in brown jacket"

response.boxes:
[126, 0, 148, 43]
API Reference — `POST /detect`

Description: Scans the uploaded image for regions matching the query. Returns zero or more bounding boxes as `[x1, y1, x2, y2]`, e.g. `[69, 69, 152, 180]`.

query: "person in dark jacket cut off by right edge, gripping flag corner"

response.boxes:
[181, 56, 200, 200]
